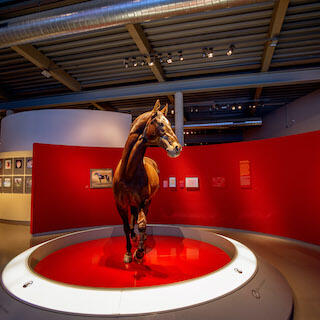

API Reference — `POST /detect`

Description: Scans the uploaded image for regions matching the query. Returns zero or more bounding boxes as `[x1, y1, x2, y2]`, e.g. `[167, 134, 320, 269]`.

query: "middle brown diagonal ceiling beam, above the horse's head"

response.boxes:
[126, 23, 174, 110]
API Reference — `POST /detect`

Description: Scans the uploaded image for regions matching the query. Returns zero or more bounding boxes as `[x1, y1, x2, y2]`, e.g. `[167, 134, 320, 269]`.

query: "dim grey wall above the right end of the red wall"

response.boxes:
[243, 90, 320, 140]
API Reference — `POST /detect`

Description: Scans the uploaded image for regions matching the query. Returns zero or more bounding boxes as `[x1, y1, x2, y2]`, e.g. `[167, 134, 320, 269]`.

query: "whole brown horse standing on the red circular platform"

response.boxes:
[113, 100, 182, 263]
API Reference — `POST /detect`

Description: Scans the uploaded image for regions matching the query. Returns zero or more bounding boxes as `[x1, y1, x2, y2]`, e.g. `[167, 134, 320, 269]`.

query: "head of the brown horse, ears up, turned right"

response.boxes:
[142, 100, 182, 158]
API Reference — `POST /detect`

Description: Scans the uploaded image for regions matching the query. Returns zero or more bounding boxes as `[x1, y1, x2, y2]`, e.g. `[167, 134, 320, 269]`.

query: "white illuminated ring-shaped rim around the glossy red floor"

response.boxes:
[2, 226, 292, 319]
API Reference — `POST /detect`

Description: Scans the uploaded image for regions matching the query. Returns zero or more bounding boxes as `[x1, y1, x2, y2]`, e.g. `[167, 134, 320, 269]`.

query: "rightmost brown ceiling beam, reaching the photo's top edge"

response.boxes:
[254, 0, 290, 100]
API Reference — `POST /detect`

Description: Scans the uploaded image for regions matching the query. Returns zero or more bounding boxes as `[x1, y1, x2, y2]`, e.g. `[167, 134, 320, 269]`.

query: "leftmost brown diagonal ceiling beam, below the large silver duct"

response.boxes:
[11, 44, 81, 91]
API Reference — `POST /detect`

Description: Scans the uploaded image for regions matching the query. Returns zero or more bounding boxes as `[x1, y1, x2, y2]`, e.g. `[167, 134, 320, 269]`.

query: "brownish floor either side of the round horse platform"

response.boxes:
[0, 222, 320, 320]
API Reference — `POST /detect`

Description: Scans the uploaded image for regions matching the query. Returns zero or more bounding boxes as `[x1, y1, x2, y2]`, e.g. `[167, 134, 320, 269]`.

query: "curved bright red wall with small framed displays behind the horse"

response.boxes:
[31, 131, 320, 244]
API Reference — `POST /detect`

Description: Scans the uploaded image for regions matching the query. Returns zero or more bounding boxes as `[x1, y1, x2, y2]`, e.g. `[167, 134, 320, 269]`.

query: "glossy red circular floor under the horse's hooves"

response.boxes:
[35, 235, 230, 288]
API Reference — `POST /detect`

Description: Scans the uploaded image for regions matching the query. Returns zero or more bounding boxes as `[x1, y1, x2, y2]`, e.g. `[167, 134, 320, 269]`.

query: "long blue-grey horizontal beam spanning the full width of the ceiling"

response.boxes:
[0, 68, 320, 110]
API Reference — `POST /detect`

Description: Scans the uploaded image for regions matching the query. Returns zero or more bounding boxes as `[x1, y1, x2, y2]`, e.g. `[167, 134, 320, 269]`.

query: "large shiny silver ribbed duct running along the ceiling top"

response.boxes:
[0, 0, 266, 48]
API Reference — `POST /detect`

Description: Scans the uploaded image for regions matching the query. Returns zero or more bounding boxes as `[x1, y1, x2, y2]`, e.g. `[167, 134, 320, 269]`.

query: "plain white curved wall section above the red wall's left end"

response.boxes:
[0, 109, 131, 152]
